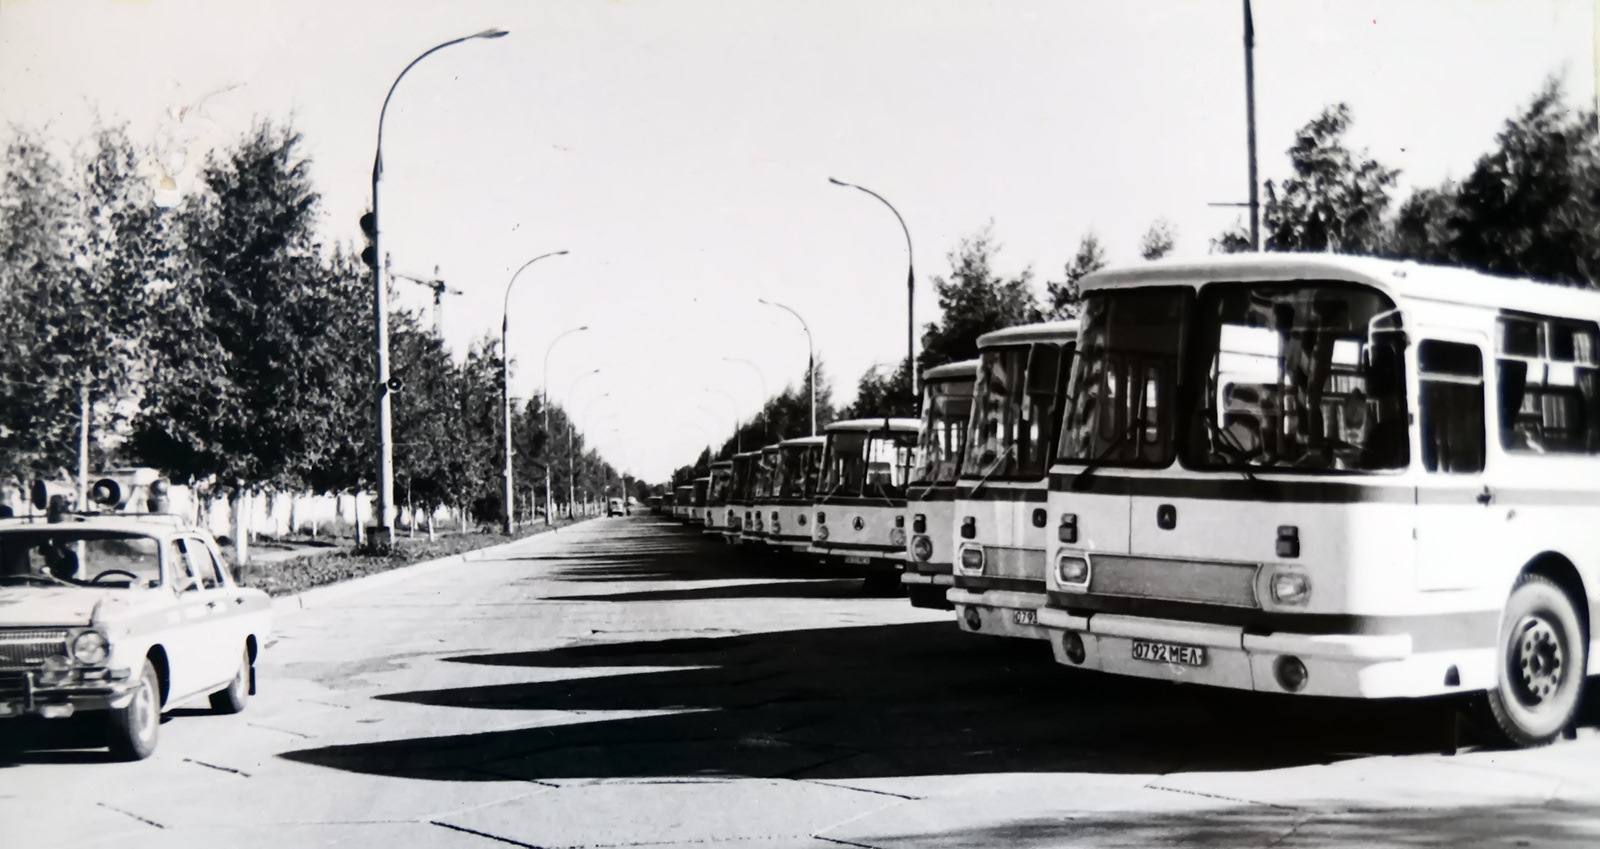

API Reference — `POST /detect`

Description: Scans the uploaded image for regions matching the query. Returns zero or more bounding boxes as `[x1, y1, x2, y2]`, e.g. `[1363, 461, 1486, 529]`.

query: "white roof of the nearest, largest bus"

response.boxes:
[1082, 253, 1600, 315]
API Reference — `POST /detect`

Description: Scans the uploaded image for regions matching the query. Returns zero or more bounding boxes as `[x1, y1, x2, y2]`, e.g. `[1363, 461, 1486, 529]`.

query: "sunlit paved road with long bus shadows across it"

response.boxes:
[0, 516, 1600, 849]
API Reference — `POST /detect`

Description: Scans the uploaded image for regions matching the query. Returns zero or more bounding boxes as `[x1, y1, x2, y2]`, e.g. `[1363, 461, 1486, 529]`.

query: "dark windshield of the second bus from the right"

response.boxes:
[962, 342, 1075, 480]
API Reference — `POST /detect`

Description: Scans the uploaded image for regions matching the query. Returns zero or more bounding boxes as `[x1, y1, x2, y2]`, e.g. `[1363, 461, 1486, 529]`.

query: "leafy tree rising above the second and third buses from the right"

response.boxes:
[907, 222, 1043, 369]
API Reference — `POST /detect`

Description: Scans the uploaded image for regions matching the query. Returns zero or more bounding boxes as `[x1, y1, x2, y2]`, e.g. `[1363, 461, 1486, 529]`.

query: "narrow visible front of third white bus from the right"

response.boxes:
[901, 360, 978, 611]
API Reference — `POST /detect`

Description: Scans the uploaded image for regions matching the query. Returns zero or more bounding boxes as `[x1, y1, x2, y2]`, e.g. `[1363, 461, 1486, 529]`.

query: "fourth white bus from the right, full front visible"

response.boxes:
[810, 419, 920, 587]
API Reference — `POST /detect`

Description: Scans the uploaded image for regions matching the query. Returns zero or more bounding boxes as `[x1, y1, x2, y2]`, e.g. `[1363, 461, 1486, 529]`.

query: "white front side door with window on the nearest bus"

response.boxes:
[1414, 331, 1497, 590]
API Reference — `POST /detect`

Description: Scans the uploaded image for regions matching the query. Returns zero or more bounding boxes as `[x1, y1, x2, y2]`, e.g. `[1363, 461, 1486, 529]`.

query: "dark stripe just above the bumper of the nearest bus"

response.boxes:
[1050, 592, 1501, 652]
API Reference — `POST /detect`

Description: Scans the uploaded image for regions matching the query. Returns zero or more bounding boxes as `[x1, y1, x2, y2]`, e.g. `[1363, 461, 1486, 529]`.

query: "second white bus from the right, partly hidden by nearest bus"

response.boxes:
[946, 321, 1078, 640]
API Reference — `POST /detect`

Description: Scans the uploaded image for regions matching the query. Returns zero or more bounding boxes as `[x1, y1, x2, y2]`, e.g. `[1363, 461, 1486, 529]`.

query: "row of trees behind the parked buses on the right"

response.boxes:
[659, 80, 1600, 484]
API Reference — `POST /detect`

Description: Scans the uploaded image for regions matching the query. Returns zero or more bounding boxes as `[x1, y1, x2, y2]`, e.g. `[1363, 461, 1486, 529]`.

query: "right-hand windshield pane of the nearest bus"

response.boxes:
[1182, 283, 1410, 472]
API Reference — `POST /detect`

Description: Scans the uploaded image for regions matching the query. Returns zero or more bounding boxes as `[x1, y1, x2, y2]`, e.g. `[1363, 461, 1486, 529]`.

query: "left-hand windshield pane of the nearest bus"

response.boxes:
[1058, 286, 1192, 467]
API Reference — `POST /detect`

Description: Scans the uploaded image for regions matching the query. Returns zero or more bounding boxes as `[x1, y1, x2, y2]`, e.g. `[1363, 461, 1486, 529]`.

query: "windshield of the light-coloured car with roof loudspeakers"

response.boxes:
[0, 529, 162, 587]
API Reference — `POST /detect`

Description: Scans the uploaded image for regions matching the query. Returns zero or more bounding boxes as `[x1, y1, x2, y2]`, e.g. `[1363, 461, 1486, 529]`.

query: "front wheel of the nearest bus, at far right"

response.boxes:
[1488, 574, 1589, 747]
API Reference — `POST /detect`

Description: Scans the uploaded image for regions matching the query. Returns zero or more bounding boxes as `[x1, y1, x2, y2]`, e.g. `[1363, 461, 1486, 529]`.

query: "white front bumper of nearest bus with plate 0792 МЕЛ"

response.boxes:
[1038, 608, 1472, 699]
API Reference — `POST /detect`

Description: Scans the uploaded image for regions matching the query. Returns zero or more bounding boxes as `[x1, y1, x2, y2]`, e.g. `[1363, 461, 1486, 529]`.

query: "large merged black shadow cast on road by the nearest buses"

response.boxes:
[285, 622, 1472, 780]
